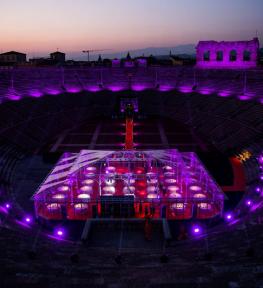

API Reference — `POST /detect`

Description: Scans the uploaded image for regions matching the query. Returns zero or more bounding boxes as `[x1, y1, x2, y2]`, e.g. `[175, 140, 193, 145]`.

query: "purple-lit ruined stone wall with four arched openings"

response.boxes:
[196, 38, 259, 69]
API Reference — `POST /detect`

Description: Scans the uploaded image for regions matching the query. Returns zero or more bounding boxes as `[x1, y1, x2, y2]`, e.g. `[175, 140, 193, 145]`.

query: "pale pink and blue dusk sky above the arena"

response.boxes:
[0, 0, 263, 56]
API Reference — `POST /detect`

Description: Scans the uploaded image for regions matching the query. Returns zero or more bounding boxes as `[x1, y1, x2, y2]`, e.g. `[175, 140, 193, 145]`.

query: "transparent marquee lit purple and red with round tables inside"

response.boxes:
[33, 149, 224, 220]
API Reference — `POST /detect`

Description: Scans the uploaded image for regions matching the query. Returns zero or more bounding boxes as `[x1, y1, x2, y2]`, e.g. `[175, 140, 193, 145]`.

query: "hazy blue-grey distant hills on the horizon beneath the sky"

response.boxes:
[67, 44, 195, 60]
